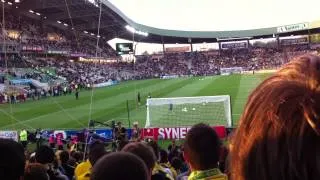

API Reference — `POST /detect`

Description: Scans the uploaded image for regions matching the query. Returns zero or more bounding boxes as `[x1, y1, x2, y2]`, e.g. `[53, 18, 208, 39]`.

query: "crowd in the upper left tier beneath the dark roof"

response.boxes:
[0, 14, 116, 57]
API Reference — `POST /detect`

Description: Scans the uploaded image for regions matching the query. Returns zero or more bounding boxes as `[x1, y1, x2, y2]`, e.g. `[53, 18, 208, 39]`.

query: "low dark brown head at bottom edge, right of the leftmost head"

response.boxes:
[23, 163, 49, 180]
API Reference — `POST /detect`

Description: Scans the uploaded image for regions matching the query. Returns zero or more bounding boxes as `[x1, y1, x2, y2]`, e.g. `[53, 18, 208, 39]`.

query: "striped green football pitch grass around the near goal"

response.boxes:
[0, 74, 268, 130]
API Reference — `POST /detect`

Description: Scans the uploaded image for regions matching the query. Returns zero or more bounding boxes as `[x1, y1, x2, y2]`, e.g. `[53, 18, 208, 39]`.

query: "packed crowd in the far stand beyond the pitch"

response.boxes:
[28, 46, 317, 83]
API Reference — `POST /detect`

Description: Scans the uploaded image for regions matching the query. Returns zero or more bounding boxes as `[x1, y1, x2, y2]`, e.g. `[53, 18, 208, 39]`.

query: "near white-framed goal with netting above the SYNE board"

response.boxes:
[146, 95, 232, 128]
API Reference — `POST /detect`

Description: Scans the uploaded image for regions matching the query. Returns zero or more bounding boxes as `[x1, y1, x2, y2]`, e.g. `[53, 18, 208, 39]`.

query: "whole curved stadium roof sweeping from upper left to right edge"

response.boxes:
[8, 0, 320, 44]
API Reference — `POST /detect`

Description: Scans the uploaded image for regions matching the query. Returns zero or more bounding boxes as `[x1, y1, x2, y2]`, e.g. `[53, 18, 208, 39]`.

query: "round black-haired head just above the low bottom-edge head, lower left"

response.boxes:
[35, 146, 55, 164]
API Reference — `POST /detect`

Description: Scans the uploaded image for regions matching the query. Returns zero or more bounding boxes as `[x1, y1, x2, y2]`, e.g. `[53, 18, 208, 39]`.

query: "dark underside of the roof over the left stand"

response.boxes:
[11, 0, 127, 39]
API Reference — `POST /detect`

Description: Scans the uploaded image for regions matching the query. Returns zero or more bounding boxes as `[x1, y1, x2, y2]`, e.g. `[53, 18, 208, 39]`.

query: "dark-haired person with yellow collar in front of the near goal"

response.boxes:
[183, 123, 228, 180]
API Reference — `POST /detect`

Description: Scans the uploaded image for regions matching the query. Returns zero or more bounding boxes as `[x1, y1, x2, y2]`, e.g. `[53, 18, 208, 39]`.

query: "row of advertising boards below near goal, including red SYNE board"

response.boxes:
[0, 126, 233, 142]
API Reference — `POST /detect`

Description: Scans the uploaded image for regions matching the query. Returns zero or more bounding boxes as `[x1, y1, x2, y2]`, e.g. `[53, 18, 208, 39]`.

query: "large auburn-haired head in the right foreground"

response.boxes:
[229, 56, 320, 180]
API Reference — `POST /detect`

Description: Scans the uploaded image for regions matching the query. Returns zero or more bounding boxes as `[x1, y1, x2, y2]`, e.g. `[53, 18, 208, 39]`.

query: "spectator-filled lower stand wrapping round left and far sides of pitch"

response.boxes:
[0, 45, 318, 103]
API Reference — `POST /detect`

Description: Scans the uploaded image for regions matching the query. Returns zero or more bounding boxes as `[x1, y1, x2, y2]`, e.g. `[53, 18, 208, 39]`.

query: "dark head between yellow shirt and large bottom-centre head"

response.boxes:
[89, 141, 107, 166]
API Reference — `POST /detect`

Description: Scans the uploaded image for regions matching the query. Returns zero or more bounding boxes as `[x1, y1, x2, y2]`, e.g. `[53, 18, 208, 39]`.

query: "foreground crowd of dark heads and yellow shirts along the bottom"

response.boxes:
[0, 121, 227, 180]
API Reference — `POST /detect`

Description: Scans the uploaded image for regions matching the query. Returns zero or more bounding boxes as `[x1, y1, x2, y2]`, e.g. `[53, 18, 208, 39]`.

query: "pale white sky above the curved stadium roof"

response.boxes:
[109, 0, 320, 31]
